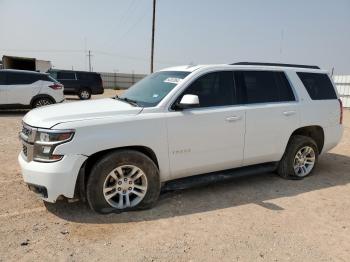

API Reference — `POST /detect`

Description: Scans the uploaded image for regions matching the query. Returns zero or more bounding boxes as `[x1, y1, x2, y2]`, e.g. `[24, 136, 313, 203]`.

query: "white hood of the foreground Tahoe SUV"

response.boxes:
[23, 98, 142, 128]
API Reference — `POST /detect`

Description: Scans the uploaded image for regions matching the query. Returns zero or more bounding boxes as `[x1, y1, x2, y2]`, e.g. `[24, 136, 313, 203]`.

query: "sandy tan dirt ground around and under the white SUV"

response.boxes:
[0, 89, 350, 261]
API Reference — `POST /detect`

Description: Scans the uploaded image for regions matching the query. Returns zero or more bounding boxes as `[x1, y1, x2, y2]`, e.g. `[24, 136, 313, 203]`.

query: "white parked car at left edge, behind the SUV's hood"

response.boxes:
[0, 69, 64, 109]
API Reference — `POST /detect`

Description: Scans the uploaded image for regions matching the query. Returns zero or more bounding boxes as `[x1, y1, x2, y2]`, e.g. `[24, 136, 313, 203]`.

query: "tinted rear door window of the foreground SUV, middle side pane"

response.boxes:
[236, 71, 295, 104]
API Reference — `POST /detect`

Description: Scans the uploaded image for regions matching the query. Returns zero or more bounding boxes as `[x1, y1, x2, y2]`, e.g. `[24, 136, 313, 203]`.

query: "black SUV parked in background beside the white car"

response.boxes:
[49, 69, 104, 100]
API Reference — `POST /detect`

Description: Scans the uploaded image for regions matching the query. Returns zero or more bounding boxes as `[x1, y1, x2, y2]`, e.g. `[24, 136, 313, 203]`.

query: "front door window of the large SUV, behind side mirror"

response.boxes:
[177, 71, 237, 107]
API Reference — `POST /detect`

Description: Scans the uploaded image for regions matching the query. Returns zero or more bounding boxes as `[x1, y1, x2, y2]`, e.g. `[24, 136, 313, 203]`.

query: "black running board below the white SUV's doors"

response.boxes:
[161, 162, 278, 192]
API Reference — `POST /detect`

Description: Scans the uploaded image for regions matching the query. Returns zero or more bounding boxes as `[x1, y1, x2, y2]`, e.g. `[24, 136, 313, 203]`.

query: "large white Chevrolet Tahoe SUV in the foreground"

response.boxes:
[18, 63, 342, 213]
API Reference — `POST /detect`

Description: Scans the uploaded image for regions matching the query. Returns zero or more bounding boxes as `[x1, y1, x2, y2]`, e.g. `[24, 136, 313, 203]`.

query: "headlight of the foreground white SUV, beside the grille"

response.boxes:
[33, 129, 74, 162]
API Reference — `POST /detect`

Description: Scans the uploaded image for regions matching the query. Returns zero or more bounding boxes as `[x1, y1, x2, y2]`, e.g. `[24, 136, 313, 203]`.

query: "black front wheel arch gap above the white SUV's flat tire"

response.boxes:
[74, 145, 159, 201]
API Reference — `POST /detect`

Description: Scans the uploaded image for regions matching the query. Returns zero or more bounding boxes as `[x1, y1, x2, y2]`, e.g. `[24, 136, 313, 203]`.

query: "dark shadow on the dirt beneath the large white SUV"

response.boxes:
[46, 153, 350, 224]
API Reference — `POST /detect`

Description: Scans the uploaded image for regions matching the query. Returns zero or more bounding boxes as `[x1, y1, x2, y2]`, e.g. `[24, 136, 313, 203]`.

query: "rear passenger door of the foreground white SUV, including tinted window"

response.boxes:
[235, 71, 299, 165]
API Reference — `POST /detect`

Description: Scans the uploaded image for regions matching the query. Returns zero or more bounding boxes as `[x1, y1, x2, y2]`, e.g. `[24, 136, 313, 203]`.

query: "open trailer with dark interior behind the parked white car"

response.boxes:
[2, 55, 52, 73]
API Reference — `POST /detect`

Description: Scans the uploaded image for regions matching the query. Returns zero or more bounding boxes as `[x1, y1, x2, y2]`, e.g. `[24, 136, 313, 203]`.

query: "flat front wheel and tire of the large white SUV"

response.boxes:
[86, 150, 160, 214]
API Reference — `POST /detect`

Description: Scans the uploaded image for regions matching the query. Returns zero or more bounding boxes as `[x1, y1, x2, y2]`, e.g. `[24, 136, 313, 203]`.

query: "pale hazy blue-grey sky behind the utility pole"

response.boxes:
[0, 0, 350, 74]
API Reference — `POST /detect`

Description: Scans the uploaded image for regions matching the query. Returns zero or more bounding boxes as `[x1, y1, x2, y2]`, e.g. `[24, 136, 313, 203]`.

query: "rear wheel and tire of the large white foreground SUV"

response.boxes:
[277, 135, 319, 179]
